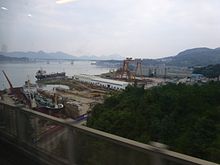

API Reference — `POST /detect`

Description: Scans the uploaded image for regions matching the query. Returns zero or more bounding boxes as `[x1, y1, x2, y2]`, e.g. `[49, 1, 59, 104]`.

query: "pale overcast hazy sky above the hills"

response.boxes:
[0, 0, 220, 58]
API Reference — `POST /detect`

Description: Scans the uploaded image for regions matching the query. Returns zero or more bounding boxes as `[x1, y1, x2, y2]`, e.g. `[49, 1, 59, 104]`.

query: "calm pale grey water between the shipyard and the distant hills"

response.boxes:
[0, 61, 111, 89]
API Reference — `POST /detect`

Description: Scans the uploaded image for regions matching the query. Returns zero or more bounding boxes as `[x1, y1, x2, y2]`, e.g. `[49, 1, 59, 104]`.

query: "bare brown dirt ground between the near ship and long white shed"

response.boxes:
[40, 79, 111, 118]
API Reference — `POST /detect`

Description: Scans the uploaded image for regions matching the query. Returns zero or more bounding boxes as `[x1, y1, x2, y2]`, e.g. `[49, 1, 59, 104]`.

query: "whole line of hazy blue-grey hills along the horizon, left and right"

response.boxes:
[0, 47, 220, 67]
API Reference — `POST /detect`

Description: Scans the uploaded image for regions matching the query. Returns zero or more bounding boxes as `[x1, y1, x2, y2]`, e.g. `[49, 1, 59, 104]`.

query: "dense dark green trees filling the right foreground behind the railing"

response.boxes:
[87, 82, 220, 163]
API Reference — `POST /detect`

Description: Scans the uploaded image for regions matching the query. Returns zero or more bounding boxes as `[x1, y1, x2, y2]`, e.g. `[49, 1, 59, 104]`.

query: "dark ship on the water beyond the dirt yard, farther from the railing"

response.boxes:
[35, 69, 66, 80]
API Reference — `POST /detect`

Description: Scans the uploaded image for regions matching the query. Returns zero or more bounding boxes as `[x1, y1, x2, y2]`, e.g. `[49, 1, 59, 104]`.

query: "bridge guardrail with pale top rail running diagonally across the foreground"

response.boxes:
[0, 101, 217, 165]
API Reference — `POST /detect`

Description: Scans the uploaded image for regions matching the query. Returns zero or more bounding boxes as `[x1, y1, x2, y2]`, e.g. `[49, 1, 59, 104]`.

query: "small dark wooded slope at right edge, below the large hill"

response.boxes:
[193, 64, 220, 78]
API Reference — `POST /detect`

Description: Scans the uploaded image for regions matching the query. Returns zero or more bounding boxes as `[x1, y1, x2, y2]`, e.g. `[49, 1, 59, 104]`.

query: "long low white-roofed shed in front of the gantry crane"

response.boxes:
[73, 74, 131, 90]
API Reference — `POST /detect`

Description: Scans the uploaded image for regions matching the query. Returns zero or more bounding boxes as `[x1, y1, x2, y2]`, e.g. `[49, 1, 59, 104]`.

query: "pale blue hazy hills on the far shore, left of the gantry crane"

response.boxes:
[0, 51, 123, 60]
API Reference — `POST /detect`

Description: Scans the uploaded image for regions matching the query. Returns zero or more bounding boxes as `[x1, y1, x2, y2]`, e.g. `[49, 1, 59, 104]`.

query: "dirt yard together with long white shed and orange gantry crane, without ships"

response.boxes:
[35, 58, 168, 119]
